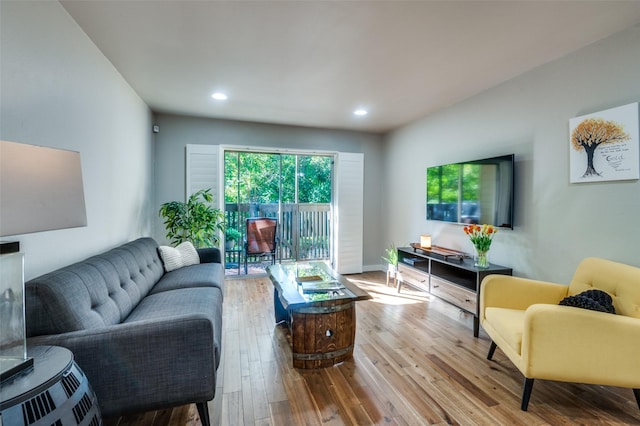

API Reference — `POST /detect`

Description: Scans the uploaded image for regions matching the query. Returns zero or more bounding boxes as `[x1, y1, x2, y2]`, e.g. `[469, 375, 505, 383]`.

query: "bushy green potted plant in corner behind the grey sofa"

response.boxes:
[160, 189, 226, 248]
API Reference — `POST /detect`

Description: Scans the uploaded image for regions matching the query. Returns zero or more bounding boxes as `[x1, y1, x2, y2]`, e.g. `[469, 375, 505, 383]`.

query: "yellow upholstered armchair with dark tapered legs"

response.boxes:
[480, 258, 640, 411]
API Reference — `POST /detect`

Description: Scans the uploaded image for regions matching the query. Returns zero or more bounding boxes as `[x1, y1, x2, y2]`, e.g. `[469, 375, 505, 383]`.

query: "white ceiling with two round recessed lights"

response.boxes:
[61, 0, 640, 132]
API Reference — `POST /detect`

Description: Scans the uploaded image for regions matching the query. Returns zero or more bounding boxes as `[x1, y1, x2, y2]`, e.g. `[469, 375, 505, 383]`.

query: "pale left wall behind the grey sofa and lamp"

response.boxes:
[0, 0, 153, 279]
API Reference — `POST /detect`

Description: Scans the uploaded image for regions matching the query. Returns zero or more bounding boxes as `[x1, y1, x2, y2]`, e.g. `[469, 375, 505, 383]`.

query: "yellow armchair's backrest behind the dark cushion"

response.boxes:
[569, 257, 640, 318]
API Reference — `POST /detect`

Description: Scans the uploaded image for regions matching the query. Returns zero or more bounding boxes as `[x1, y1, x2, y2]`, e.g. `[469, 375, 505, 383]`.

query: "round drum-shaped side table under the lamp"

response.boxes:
[0, 346, 102, 426]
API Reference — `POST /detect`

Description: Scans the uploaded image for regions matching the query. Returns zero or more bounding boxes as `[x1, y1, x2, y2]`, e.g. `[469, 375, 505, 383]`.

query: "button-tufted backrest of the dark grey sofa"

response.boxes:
[25, 238, 164, 337]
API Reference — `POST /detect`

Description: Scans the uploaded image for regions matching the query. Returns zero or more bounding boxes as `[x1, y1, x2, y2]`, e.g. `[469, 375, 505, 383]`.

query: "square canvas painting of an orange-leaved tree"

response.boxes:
[569, 102, 640, 183]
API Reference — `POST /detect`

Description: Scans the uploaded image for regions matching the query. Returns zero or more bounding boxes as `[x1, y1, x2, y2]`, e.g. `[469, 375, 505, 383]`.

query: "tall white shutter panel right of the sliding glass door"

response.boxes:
[333, 152, 364, 274]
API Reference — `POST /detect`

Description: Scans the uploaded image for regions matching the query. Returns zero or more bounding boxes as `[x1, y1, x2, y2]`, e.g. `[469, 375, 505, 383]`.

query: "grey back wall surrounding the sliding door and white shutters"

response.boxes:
[154, 114, 384, 270]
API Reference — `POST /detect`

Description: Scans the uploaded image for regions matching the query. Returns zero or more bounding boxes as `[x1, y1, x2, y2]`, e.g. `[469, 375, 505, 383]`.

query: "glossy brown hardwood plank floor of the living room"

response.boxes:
[105, 272, 640, 426]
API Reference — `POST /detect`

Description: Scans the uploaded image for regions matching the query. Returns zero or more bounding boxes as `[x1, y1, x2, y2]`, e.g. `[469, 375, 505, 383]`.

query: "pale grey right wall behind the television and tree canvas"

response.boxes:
[385, 25, 640, 283]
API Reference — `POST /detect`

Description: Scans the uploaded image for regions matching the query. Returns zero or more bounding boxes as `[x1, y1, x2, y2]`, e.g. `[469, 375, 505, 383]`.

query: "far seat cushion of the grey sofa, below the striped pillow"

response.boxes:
[150, 263, 224, 294]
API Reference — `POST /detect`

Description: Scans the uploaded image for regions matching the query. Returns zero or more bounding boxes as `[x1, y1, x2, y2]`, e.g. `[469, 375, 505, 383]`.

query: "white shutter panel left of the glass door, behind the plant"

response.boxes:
[185, 145, 221, 208]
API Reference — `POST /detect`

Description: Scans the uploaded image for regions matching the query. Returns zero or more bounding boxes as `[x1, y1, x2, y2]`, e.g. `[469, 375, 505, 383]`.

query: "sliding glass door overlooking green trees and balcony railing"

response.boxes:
[224, 151, 333, 269]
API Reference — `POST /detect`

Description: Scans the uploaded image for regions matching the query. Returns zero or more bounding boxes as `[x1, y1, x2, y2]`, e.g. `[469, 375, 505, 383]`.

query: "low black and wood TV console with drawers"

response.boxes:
[397, 247, 513, 337]
